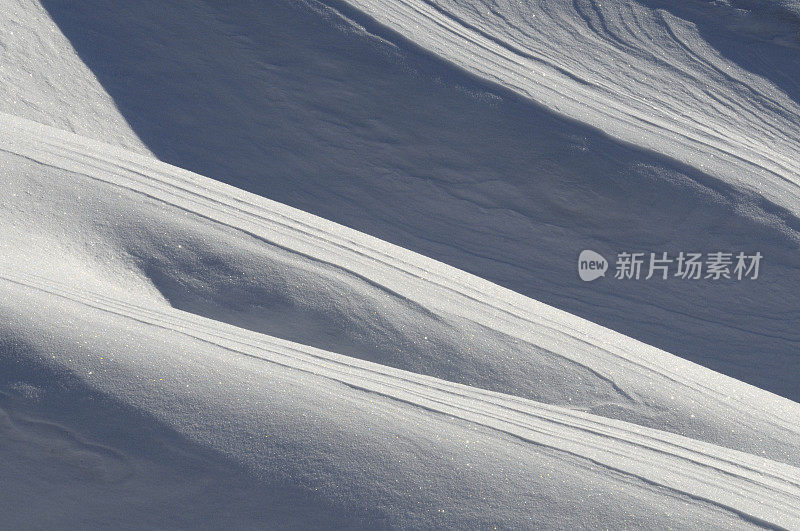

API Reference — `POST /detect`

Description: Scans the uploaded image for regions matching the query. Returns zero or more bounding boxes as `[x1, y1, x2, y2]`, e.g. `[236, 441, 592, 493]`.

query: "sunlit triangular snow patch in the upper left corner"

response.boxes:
[0, 0, 149, 153]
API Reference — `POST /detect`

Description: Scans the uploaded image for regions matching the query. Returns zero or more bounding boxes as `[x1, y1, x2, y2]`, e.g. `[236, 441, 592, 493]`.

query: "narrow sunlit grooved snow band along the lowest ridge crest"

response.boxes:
[2, 274, 800, 527]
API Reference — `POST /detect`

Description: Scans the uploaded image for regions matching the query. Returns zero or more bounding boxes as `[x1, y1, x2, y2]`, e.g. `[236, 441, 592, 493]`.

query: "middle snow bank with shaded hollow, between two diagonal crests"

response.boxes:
[6, 116, 800, 465]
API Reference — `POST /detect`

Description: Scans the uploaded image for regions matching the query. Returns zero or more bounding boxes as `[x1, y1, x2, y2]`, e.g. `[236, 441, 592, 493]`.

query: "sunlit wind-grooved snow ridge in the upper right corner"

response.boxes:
[333, 0, 800, 214]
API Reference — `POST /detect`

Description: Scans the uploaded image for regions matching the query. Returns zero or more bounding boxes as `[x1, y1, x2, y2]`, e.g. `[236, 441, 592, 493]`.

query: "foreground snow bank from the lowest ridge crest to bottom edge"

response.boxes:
[6, 276, 800, 528]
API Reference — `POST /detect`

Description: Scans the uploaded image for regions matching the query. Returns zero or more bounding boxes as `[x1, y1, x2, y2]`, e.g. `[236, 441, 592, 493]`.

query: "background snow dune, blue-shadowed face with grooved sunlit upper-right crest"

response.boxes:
[34, 0, 800, 401]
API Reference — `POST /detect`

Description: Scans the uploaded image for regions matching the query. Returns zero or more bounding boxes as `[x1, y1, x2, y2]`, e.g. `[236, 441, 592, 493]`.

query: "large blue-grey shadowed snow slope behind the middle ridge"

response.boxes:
[36, 1, 800, 400]
